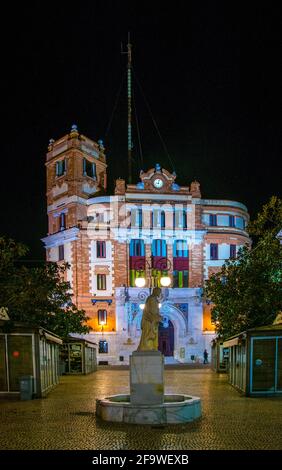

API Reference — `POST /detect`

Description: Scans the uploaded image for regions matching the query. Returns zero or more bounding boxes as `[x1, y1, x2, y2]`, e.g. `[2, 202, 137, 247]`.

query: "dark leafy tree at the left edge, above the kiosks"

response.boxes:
[0, 238, 90, 337]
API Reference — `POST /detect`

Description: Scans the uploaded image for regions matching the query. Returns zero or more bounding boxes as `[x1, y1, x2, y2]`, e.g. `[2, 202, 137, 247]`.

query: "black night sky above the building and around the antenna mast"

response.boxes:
[0, 0, 282, 260]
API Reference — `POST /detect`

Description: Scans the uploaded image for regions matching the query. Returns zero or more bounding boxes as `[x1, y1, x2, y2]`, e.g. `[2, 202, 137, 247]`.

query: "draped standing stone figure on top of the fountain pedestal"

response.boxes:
[137, 287, 162, 351]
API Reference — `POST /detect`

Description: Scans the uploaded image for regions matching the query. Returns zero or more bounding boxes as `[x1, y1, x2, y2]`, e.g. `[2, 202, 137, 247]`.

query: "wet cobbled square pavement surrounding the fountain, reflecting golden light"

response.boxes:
[0, 368, 282, 450]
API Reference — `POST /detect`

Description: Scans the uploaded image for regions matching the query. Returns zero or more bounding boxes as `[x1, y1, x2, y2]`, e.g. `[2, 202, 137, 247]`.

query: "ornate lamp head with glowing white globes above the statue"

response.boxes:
[135, 257, 171, 292]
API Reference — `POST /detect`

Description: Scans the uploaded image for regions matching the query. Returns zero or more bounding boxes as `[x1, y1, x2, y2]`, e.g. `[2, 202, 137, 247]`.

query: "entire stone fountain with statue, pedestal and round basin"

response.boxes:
[96, 288, 201, 424]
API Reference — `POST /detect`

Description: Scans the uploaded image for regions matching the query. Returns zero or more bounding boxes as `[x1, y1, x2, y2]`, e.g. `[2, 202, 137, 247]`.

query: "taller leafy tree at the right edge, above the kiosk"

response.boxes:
[205, 197, 282, 338]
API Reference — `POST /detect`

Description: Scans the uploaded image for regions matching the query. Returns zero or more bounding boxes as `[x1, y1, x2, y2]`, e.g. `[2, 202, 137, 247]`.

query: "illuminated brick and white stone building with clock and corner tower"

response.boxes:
[40, 126, 250, 364]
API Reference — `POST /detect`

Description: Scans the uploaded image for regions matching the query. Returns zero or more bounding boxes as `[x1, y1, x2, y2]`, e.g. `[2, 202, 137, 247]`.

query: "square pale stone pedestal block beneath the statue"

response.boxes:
[130, 351, 164, 405]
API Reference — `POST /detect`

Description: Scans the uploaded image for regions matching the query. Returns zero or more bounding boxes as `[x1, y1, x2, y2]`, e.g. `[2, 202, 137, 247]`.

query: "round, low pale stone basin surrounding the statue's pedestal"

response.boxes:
[96, 394, 202, 424]
